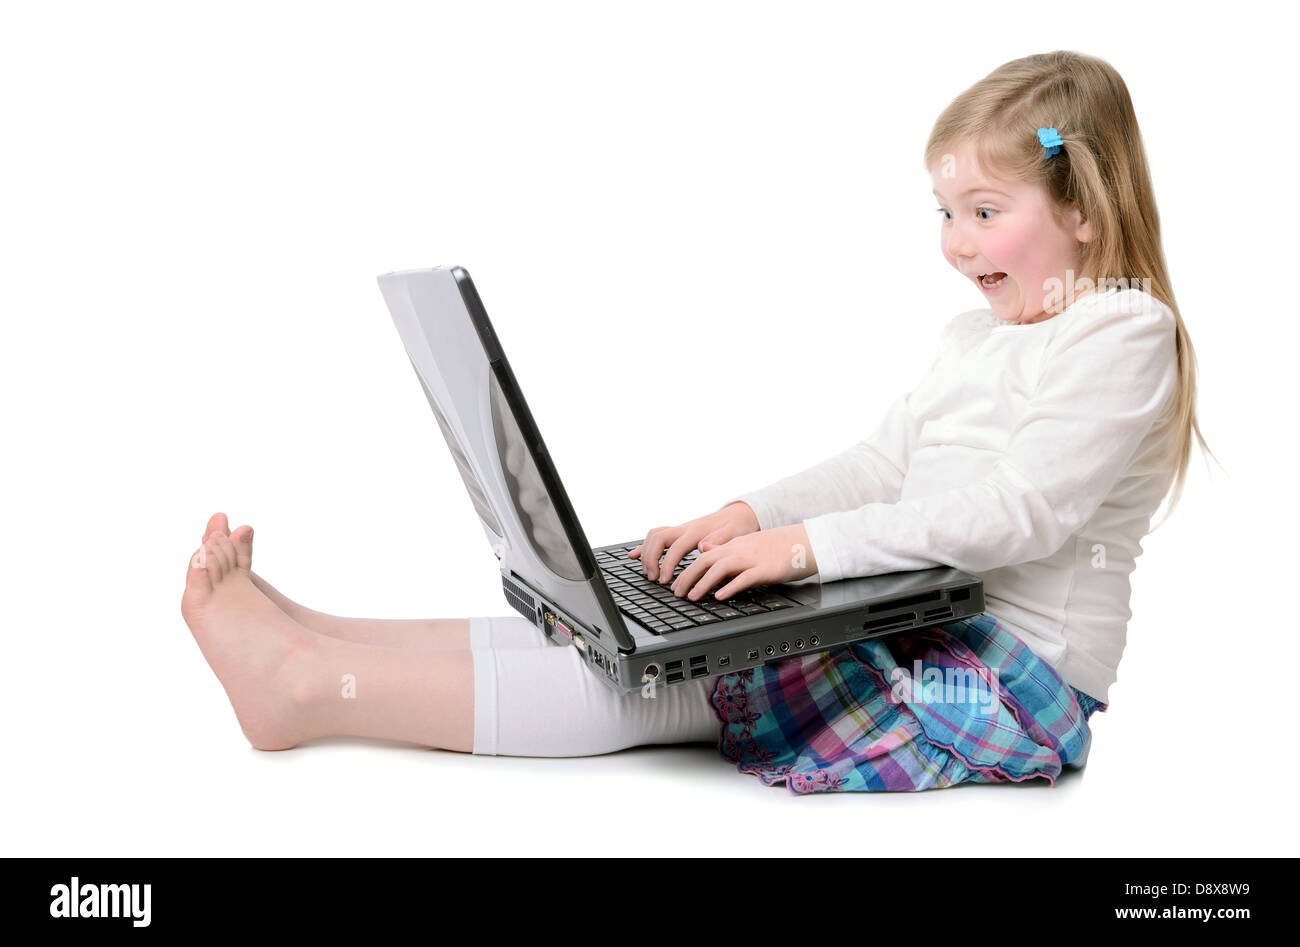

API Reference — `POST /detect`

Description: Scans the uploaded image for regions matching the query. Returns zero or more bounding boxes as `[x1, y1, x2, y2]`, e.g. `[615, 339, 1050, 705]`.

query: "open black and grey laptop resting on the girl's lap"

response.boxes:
[378, 267, 984, 696]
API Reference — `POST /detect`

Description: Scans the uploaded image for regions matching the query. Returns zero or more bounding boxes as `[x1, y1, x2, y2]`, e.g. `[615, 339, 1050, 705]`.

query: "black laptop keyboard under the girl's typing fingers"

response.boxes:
[593, 542, 816, 635]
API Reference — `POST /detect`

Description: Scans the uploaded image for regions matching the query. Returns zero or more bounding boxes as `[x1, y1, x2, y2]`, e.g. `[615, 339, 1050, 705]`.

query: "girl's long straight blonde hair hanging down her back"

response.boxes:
[926, 51, 1217, 527]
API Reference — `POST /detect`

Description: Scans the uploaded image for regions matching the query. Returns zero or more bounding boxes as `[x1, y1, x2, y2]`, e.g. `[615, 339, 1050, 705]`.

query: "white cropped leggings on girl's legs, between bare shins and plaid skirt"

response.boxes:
[469, 615, 722, 756]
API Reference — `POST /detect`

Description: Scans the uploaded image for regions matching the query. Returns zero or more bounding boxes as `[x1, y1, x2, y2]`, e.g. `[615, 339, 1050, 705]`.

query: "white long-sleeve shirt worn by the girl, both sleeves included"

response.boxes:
[728, 289, 1178, 701]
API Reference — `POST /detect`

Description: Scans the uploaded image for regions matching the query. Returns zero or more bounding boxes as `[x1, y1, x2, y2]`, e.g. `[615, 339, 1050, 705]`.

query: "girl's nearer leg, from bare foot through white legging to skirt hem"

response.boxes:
[181, 517, 719, 756]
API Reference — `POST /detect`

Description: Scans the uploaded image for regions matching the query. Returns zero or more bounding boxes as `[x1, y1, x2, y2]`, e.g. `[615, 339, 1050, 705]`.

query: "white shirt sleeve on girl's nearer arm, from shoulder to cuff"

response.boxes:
[803, 291, 1178, 583]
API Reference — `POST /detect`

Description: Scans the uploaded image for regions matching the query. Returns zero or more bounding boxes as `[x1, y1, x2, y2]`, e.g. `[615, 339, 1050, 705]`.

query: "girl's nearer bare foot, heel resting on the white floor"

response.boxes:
[181, 527, 319, 749]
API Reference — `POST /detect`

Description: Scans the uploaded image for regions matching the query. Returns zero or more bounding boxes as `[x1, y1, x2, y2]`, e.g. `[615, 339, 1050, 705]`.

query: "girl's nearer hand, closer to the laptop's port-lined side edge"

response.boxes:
[672, 523, 816, 602]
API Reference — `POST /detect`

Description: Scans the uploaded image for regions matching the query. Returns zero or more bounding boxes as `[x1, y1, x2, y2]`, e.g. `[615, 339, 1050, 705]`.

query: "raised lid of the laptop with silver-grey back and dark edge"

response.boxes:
[378, 267, 634, 652]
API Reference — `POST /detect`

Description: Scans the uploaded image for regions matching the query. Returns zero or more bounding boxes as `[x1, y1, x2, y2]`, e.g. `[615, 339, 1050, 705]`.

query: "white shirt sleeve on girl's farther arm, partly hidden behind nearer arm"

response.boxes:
[723, 382, 915, 529]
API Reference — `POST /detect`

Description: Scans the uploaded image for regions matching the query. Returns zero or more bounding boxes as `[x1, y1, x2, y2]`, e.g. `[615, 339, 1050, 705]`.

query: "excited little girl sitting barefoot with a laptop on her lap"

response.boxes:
[182, 52, 1205, 794]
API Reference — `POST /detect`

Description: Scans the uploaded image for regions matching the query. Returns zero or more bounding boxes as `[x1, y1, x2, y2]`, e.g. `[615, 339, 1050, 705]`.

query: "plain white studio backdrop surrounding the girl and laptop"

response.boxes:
[0, 0, 1297, 856]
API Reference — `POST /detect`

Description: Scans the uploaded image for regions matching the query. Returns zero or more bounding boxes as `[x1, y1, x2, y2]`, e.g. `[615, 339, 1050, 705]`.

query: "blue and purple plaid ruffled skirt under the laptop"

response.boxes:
[711, 615, 1106, 795]
